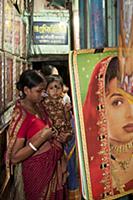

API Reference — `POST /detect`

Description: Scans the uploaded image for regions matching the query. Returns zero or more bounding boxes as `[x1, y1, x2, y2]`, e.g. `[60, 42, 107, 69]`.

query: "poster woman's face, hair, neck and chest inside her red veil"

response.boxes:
[105, 57, 133, 193]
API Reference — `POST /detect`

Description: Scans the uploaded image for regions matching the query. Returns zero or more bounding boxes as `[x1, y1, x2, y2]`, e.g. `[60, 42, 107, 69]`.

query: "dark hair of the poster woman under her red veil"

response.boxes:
[105, 57, 119, 88]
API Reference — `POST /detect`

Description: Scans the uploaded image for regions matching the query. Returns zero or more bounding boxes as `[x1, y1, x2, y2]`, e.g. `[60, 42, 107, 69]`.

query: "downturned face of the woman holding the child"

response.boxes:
[25, 83, 45, 103]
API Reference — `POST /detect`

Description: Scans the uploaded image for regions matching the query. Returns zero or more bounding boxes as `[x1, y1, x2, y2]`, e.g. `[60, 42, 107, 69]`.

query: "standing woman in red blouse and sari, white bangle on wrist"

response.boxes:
[6, 70, 67, 200]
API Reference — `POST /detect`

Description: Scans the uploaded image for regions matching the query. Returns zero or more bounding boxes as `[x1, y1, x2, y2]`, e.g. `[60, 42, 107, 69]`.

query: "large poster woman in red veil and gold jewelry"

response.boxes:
[83, 57, 133, 200]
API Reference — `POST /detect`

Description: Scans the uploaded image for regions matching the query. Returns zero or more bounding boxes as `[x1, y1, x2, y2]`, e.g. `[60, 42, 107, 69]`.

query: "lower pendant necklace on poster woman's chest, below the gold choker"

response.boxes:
[111, 154, 133, 170]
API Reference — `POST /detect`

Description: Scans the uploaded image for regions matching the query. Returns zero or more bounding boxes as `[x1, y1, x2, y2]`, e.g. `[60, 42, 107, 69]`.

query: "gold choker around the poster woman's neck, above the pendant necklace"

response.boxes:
[110, 141, 133, 153]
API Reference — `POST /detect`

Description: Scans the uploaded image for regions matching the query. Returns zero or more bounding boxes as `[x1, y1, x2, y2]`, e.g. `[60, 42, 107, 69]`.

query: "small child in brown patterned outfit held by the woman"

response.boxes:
[42, 75, 73, 141]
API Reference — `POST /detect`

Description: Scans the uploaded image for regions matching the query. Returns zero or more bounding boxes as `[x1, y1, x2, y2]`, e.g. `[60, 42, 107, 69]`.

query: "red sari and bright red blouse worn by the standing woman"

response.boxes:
[7, 101, 67, 200]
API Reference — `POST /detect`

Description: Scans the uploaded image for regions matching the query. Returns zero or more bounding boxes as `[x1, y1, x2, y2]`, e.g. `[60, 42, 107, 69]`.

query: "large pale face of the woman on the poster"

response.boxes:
[105, 78, 133, 143]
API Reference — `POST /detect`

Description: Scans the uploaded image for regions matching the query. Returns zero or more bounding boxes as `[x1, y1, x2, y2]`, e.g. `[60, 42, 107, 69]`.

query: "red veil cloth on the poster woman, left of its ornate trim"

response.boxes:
[83, 58, 110, 200]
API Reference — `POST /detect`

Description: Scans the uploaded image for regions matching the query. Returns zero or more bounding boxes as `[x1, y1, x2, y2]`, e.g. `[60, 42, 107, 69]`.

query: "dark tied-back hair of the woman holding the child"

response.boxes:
[16, 70, 46, 98]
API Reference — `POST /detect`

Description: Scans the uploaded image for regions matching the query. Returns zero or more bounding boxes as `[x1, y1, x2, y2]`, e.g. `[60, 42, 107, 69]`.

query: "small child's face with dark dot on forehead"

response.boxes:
[47, 81, 63, 99]
